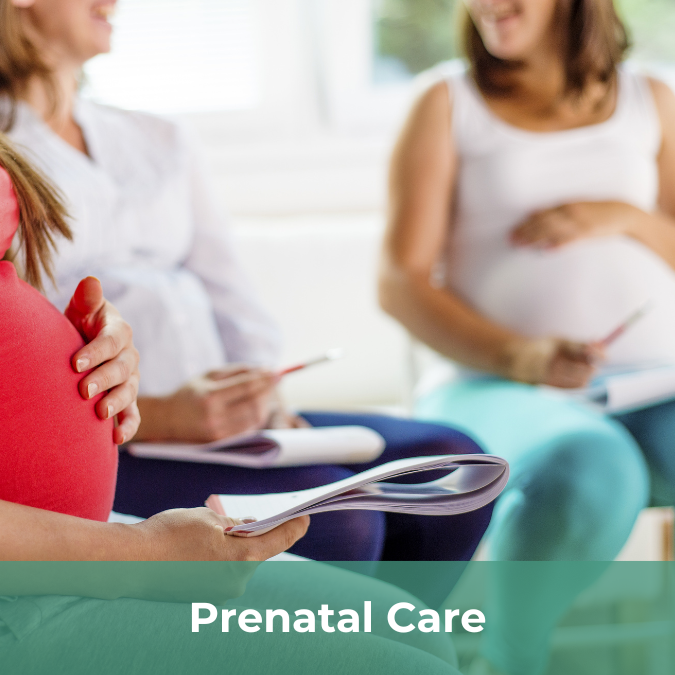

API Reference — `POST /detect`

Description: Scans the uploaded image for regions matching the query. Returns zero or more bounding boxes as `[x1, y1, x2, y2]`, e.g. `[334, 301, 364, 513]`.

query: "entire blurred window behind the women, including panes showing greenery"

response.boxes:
[79, 0, 675, 132]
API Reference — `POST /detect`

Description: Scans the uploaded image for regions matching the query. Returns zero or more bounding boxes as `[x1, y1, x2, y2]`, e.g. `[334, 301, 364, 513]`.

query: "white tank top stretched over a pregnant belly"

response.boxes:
[443, 68, 675, 367]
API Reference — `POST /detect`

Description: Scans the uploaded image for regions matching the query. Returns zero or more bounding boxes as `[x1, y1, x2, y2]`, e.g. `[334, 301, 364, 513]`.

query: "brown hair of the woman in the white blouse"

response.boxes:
[0, 0, 56, 131]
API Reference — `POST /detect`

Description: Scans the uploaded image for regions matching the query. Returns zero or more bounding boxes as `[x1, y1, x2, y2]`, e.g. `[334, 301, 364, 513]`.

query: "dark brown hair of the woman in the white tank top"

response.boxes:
[462, 0, 630, 96]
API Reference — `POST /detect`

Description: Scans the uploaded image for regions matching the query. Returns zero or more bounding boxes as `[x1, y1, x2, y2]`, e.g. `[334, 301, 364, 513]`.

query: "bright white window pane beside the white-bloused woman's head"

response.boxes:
[84, 0, 262, 113]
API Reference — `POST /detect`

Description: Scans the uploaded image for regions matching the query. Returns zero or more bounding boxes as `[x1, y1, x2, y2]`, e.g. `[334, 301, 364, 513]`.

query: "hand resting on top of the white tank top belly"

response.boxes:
[511, 202, 647, 249]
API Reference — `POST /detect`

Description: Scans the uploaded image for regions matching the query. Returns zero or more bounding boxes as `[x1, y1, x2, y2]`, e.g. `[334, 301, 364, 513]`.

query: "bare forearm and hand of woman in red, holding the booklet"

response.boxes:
[0, 500, 309, 600]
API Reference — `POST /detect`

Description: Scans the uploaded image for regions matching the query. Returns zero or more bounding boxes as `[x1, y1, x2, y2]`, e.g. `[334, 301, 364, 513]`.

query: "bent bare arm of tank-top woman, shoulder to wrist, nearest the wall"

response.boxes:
[379, 82, 519, 373]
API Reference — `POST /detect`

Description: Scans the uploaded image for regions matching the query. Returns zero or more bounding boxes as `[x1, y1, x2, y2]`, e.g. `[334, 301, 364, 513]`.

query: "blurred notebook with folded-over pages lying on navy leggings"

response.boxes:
[127, 426, 385, 469]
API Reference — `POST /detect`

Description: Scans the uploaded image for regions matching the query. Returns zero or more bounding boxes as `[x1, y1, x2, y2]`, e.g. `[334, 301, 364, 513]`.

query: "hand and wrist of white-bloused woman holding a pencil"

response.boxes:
[137, 365, 278, 443]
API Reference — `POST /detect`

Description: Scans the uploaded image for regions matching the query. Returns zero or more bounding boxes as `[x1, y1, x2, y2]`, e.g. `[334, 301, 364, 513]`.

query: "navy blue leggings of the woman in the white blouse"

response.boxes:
[114, 412, 492, 571]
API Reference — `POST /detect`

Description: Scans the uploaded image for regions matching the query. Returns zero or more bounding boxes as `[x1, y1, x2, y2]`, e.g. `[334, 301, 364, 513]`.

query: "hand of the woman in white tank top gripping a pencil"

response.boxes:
[505, 338, 603, 389]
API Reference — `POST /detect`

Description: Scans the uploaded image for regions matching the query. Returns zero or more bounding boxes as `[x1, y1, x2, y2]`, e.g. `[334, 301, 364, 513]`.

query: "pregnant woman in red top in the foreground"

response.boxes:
[0, 137, 457, 675]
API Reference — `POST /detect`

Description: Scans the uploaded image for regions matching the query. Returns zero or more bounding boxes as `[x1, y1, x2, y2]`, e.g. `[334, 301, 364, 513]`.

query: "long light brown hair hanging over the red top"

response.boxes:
[0, 133, 72, 291]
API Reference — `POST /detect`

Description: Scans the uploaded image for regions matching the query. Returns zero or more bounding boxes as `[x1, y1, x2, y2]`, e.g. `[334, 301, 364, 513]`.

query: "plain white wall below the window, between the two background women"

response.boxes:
[191, 97, 409, 408]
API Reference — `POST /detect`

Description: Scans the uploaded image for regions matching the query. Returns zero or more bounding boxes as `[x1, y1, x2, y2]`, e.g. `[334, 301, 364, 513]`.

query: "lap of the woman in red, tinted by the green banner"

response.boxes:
[0, 563, 458, 675]
